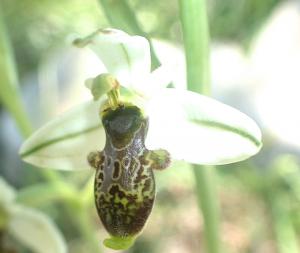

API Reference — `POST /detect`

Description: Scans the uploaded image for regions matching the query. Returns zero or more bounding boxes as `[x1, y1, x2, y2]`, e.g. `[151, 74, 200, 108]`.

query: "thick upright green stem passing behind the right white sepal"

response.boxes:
[179, 0, 221, 253]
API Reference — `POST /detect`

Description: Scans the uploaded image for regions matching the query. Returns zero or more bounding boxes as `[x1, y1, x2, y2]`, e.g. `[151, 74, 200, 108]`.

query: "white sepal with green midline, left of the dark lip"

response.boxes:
[20, 100, 105, 170]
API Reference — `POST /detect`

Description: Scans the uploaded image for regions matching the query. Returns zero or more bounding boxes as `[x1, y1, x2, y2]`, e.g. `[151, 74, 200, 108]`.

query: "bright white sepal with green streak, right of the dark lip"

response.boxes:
[146, 89, 262, 165]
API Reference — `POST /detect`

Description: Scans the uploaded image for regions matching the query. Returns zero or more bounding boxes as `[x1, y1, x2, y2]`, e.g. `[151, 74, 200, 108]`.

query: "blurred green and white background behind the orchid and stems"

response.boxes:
[0, 0, 300, 253]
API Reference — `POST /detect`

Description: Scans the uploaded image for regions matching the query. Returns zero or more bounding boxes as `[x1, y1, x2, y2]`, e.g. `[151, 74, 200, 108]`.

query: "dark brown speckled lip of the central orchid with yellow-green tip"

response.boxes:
[88, 85, 170, 249]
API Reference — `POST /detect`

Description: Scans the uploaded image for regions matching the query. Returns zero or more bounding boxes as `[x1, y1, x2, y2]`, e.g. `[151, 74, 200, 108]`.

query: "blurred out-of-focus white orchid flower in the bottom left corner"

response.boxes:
[0, 177, 67, 253]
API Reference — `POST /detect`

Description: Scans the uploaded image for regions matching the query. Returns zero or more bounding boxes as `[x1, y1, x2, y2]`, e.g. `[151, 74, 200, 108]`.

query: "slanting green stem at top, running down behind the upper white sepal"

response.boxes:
[98, 0, 160, 70]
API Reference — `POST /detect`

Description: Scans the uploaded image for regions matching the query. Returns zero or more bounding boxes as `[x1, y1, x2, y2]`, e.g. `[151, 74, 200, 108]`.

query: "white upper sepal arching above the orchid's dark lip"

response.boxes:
[77, 29, 151, 88]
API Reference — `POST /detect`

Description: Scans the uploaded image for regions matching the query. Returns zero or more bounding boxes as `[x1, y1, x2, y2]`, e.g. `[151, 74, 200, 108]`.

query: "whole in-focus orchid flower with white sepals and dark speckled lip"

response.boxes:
[20, 29, 262, 249]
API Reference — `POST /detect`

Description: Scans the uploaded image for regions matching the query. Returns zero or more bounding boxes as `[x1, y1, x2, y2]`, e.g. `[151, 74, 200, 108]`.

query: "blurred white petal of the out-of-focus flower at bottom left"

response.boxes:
[8, 206, 67, 253]
